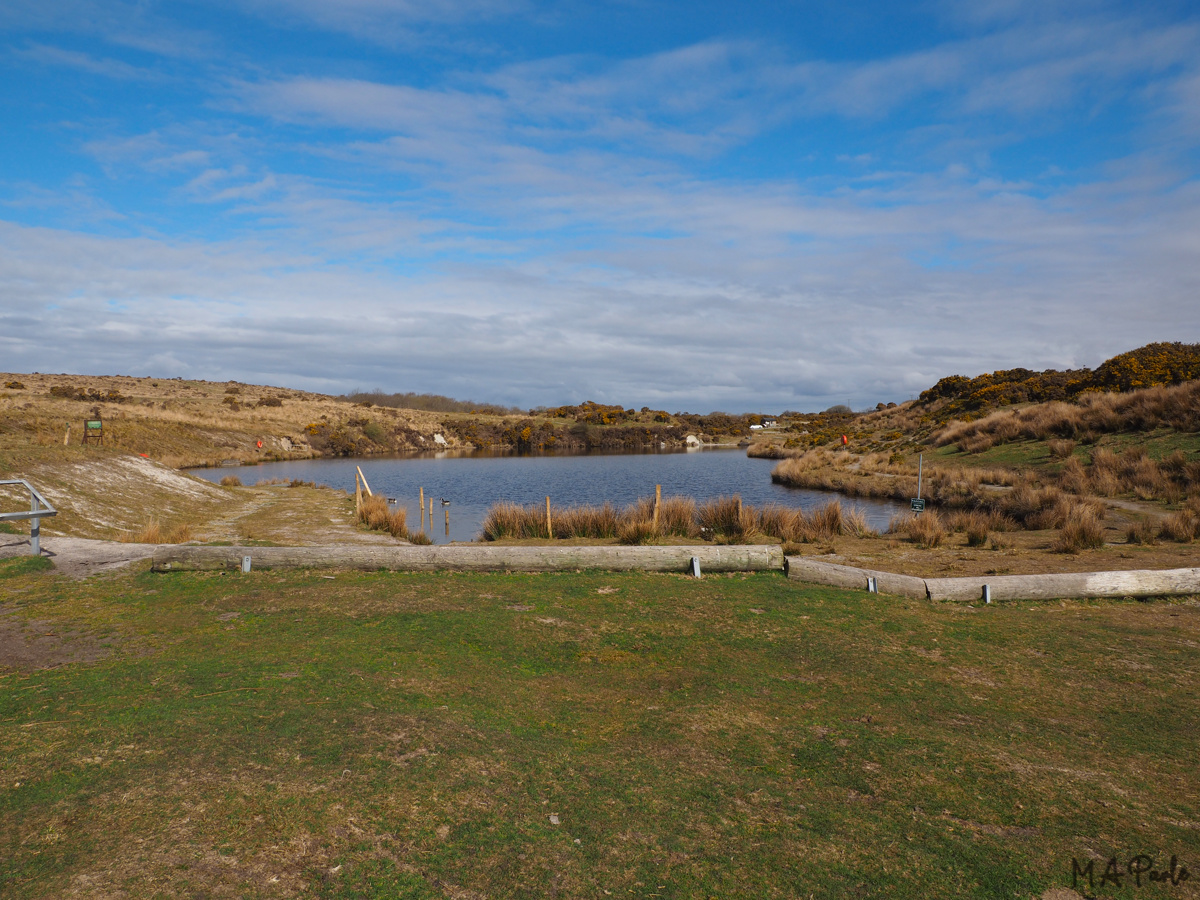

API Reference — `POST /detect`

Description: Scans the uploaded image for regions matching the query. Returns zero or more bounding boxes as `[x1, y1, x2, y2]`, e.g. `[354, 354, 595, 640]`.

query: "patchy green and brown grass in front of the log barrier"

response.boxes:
[0, 559, 1200, 899]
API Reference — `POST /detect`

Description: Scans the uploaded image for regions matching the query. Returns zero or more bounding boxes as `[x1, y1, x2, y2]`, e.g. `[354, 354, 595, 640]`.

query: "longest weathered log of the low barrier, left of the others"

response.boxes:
[151, 544, 784, 574]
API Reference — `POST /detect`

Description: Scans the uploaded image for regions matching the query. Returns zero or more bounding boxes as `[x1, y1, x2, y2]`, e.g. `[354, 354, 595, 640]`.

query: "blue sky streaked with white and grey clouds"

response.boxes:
[0, 0, 1200, 412]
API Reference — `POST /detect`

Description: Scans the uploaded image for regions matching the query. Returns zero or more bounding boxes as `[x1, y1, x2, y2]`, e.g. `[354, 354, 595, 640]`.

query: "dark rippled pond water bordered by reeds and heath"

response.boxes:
[192, 450, 902, 544]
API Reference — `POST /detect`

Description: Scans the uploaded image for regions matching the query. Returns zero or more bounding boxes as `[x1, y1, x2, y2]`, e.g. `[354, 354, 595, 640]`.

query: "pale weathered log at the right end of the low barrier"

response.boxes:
[925, 569, 1200, 601]
